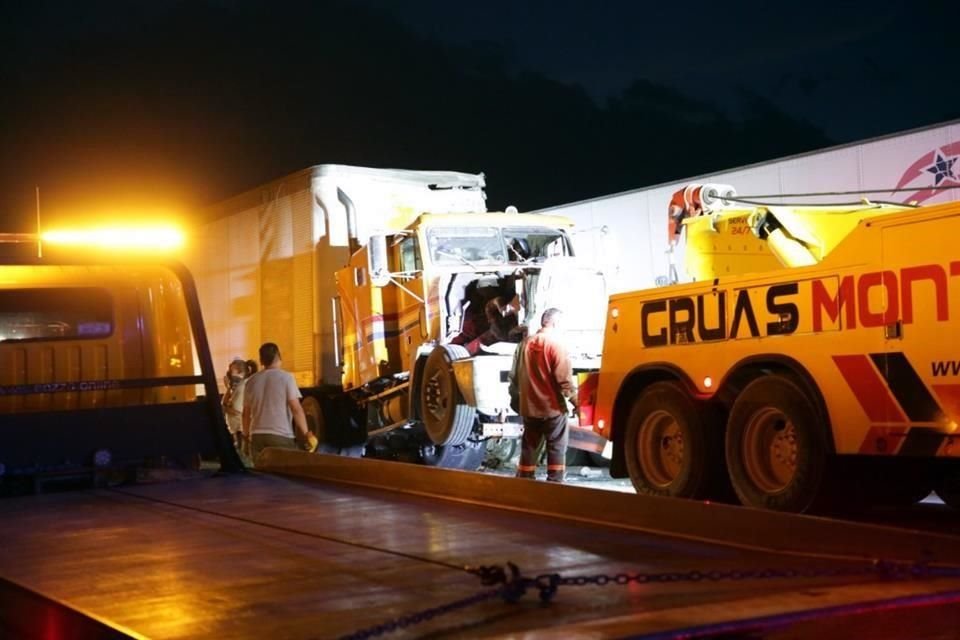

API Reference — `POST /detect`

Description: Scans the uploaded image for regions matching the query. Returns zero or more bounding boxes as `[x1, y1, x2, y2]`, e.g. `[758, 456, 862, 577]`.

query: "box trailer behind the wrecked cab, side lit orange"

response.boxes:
[185, 164, 486, 387]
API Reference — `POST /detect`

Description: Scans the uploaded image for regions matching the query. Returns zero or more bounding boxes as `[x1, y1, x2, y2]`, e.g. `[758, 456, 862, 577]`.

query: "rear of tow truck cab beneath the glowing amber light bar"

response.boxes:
[0, 245, 238, 480]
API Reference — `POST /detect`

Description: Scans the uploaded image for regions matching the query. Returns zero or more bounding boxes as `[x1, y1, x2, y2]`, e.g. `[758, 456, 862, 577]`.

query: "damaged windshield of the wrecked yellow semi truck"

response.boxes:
[427, 227, 571, 265]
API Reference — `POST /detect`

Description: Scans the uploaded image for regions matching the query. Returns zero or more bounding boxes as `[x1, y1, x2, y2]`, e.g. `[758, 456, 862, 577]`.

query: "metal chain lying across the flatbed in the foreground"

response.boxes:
[342, 560, 960, 640]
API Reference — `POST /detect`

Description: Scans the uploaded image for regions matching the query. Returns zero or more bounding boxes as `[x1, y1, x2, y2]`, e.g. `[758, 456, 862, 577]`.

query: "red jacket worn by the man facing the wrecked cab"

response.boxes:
[517, 327, 577, 418]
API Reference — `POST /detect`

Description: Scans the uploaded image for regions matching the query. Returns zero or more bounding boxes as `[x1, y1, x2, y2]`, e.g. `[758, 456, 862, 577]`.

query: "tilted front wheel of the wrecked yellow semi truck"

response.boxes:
[420, 344, 477, 446]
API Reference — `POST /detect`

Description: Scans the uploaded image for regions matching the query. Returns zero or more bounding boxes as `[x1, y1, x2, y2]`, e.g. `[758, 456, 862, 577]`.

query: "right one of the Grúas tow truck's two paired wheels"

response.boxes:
[726, 374, 827, 513]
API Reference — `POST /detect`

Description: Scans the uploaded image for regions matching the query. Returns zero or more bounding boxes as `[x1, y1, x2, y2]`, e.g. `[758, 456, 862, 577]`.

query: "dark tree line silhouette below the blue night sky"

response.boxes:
[0, 0, 830, 221]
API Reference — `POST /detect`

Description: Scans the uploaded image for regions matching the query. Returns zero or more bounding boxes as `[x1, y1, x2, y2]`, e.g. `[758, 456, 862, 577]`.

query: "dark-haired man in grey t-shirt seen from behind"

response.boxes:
[243, 342, 317, 464]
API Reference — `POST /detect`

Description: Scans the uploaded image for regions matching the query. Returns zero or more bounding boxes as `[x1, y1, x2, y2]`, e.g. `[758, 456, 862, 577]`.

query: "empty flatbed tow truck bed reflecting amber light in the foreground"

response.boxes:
[0, 451, 960, 640]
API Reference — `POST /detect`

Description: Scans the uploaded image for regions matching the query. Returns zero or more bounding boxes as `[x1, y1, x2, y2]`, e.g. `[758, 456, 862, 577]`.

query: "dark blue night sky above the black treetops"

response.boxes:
[365, 0, 960, 141]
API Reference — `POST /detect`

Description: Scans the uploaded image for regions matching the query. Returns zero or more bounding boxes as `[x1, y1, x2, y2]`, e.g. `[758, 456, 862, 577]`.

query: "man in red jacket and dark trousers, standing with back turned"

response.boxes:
[511, 308, 577, 482]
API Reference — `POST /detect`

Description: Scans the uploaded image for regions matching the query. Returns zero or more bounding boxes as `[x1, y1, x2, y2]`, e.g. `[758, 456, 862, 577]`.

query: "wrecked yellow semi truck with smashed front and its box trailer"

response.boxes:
[187, 165, 606, 469]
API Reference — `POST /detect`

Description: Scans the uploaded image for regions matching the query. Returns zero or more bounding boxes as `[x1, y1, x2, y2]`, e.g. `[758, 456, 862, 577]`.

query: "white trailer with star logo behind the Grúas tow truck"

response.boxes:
[538, 121, 960, 293]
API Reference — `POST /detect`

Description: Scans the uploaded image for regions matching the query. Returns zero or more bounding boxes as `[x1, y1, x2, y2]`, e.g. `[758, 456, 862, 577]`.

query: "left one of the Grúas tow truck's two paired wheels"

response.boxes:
[623, 381, 724, 499]
